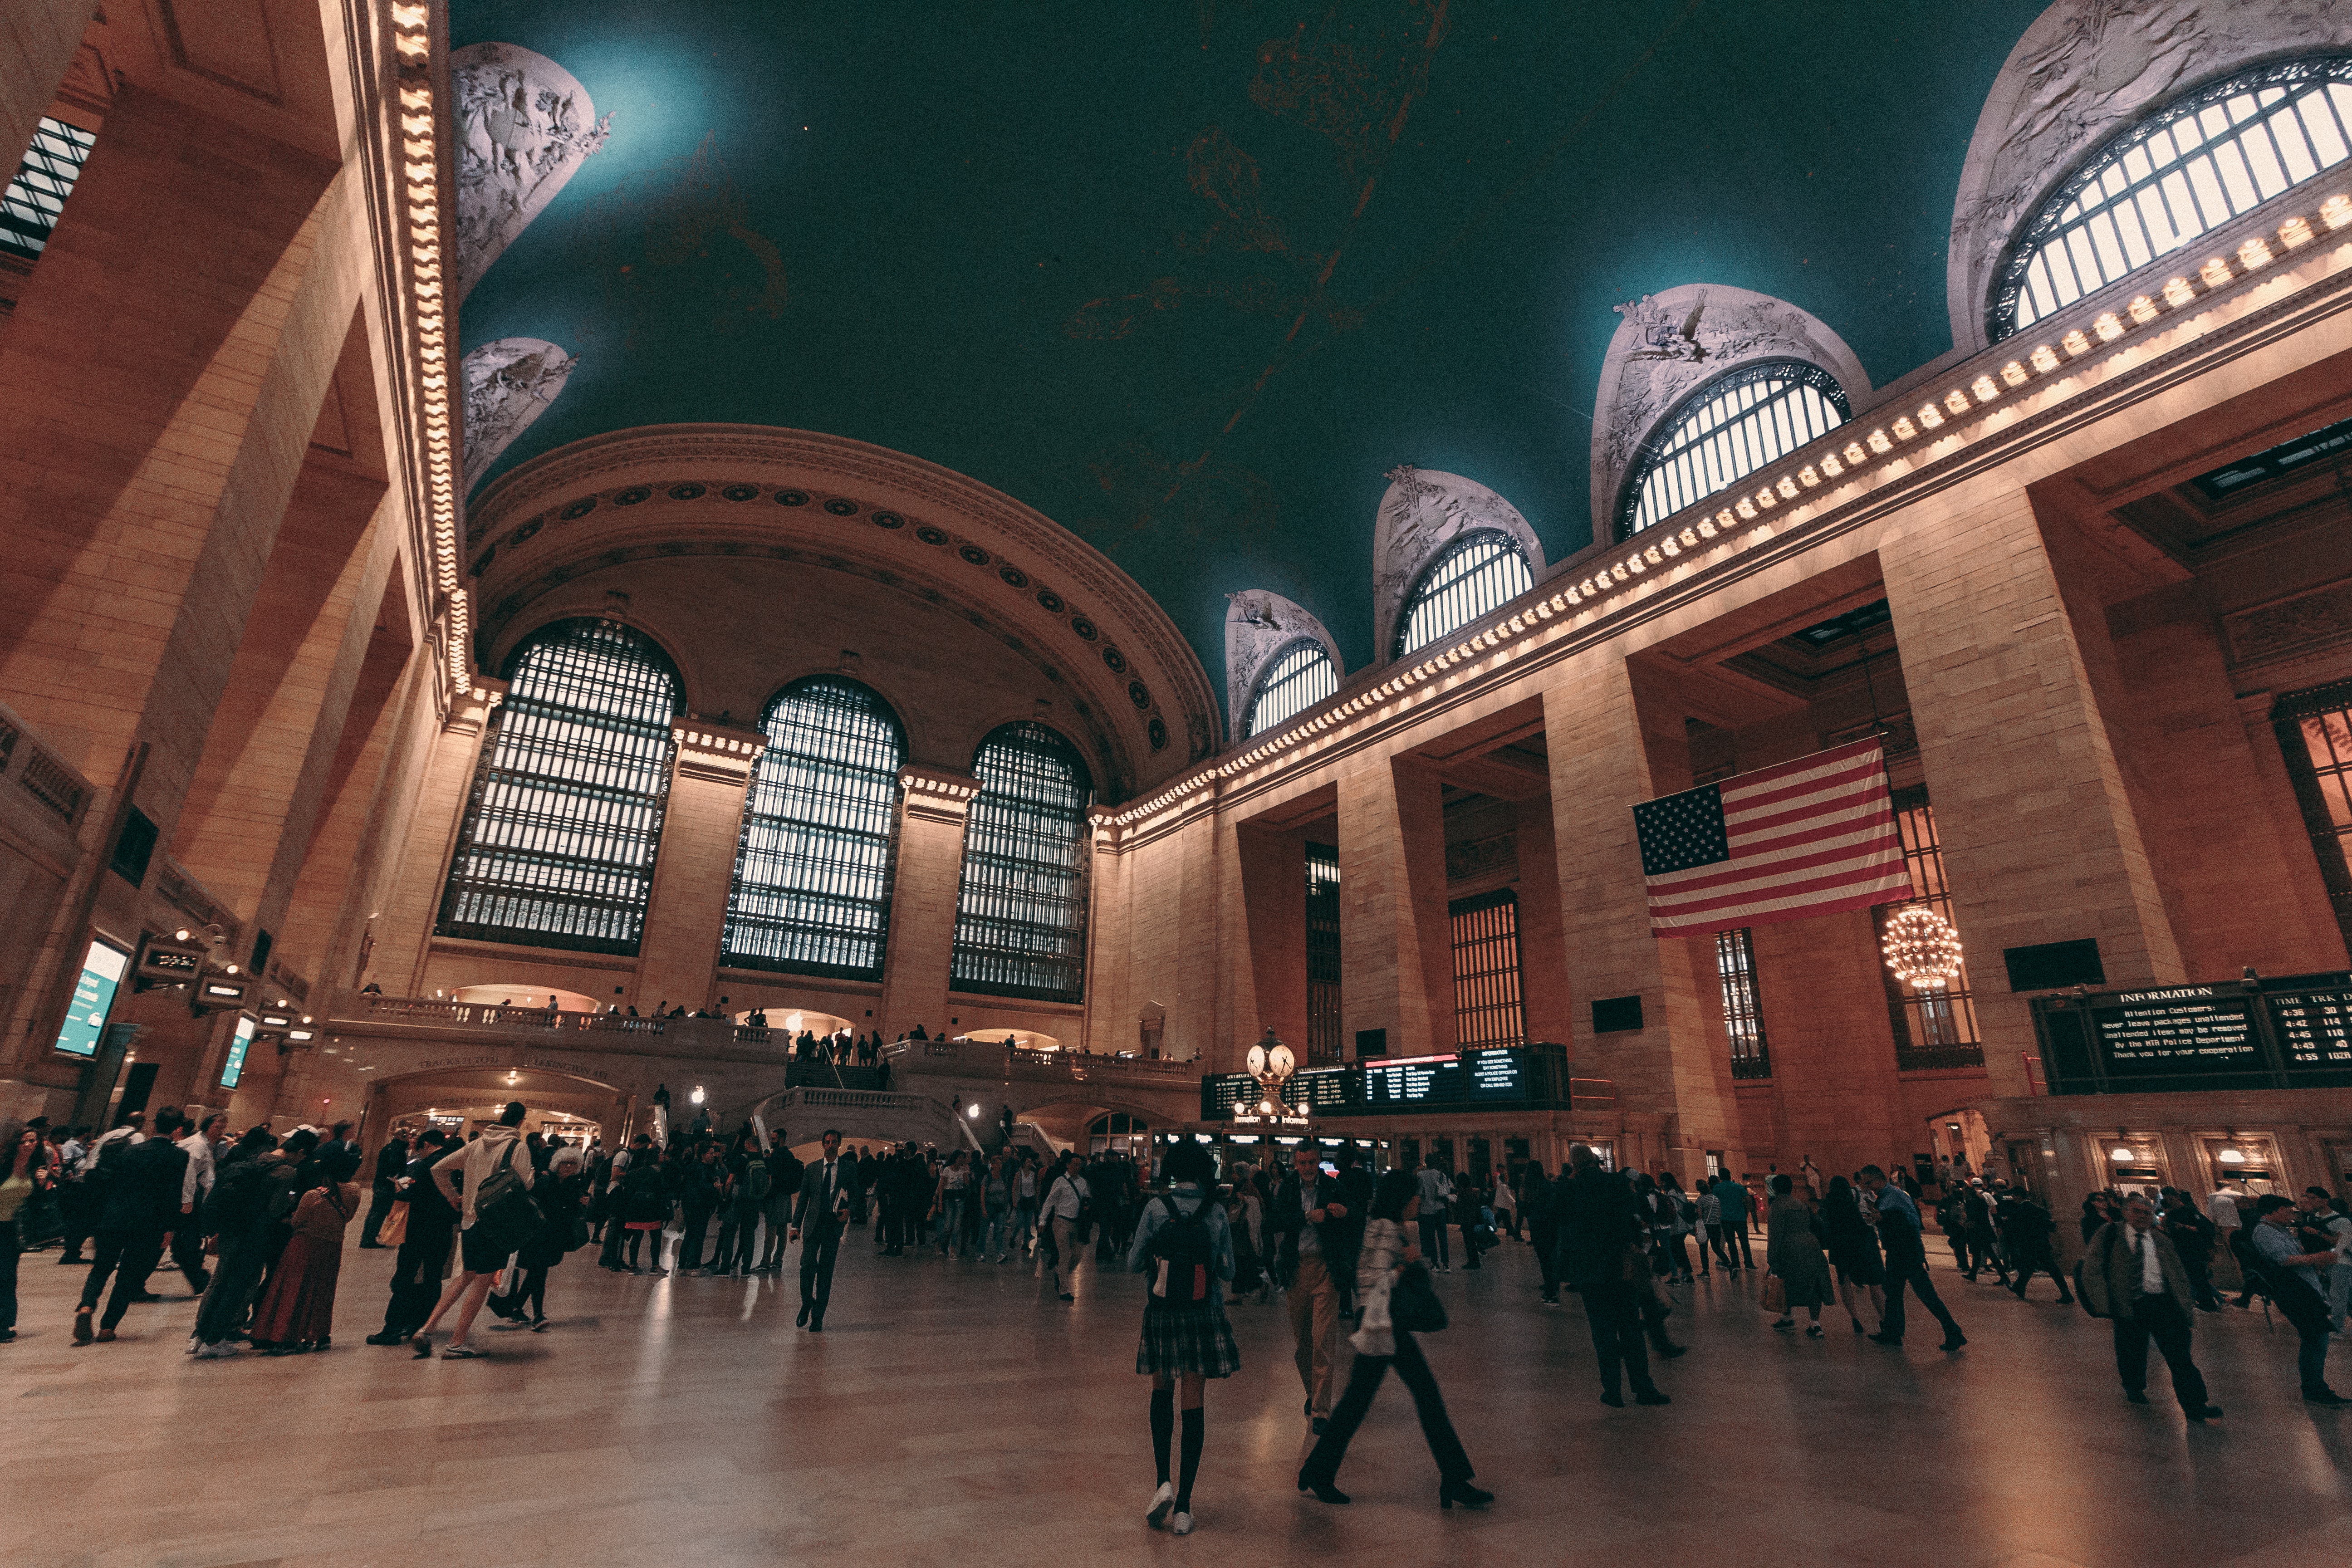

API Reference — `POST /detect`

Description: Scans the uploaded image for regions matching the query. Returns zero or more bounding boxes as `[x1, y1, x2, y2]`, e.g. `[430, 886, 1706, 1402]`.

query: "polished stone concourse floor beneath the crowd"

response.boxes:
[0, 1232, 2352, 1568]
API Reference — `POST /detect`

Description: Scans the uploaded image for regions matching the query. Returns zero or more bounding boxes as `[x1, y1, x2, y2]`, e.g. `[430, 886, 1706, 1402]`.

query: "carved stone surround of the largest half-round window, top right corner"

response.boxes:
[1945, 0, 2352, 355]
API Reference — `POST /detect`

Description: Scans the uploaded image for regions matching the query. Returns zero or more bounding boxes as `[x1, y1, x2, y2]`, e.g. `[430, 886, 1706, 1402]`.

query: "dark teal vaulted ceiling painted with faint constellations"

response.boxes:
[451, 0, 2042, 710]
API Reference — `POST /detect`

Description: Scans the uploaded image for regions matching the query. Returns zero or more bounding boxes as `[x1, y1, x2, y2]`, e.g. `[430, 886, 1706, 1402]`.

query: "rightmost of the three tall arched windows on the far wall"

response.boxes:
[948, 724, 1091, 1001]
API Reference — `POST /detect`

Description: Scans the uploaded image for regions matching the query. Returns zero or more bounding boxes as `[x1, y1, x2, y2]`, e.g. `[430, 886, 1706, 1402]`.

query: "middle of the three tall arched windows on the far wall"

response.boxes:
[720, 675, 906, 980]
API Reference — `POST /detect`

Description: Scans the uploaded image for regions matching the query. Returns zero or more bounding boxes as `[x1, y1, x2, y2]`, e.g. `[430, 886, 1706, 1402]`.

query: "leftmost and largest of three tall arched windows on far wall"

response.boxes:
[437, 621, 680, 955]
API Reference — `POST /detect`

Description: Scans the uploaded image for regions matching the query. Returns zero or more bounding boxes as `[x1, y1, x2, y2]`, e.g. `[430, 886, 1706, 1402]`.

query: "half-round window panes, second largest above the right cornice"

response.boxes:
[1618, 360, 1851, 539]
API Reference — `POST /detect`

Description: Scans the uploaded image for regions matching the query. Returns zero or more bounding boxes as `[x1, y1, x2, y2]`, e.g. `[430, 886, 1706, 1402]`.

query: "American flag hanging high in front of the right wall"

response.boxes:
[1632, 740, 1912, 936]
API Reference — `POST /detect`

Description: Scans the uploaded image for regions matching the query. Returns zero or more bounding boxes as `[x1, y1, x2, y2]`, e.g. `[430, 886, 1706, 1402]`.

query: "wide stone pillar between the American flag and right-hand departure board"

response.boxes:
[1879, 491, 2183, 1096]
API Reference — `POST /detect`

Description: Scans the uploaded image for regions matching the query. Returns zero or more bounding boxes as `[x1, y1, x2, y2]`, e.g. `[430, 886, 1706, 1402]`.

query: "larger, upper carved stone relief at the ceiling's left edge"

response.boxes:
[449, 44, 612, 303]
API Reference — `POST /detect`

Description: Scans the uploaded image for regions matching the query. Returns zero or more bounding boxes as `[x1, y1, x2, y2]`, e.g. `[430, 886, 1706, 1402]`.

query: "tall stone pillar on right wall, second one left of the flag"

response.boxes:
[1345, 757, 1454, 1055]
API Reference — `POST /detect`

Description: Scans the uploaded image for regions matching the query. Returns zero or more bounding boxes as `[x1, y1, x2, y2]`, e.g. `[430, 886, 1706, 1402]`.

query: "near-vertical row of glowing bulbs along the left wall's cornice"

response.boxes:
[391, 0, 473, 691]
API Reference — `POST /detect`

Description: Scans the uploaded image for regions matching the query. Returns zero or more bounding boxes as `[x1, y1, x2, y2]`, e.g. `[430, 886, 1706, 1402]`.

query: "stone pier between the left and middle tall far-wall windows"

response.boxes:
[635, 717, 767, 1006]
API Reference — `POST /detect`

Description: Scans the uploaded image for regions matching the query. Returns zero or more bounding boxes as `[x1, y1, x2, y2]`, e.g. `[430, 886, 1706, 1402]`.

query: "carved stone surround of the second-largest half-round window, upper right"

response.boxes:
[1592, 282, 1870, 541]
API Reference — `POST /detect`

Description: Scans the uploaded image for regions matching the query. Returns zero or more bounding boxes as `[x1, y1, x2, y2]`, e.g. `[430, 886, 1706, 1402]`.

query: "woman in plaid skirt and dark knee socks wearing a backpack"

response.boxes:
[1127, 1140, 1242, 1535]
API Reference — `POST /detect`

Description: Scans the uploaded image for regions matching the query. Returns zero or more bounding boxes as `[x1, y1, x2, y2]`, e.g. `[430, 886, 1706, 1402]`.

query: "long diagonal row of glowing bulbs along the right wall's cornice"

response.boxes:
[1105, 195, 2352, 832]
